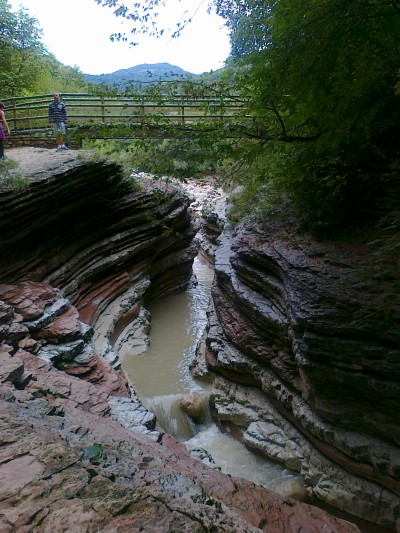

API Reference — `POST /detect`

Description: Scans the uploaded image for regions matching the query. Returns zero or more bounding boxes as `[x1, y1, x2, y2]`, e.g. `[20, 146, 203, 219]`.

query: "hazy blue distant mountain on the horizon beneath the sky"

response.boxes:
[84, 63, 198, 89]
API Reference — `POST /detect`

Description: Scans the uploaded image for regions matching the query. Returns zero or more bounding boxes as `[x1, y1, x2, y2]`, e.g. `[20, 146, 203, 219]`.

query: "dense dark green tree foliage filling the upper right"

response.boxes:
[96, 0, 400, 230]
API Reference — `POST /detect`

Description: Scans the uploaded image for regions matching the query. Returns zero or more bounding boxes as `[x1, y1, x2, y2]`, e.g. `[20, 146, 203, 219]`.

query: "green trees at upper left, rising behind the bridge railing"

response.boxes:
[0, 0, 84, 99]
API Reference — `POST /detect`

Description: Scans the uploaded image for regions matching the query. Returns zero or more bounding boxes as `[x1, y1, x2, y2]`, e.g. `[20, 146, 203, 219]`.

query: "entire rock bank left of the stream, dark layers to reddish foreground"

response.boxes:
[0, 149, 358, 533]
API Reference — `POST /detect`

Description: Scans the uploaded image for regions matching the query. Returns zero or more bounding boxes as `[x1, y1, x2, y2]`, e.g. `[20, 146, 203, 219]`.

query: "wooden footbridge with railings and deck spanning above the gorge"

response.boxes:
[3, 93, 252, 142]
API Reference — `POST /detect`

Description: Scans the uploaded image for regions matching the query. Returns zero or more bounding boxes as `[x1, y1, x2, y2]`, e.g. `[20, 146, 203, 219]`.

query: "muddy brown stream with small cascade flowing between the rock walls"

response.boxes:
[122, 258, 297, 492]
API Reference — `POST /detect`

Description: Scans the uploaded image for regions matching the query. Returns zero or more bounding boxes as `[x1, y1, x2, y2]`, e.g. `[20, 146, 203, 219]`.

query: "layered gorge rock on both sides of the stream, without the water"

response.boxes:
[0, 148, 394, 532]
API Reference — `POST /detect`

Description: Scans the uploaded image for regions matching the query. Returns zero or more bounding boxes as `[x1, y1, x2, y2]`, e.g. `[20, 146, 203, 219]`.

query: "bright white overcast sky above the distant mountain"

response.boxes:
[9, 0, 230, 74]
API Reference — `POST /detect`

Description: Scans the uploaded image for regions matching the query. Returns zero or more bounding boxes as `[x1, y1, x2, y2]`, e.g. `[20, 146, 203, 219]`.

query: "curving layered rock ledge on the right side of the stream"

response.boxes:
[194, 215, 400, 530]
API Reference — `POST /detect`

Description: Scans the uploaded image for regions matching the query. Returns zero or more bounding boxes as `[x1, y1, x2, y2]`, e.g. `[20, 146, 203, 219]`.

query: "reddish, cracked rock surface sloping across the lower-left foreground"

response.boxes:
[0, 283, 357, 533]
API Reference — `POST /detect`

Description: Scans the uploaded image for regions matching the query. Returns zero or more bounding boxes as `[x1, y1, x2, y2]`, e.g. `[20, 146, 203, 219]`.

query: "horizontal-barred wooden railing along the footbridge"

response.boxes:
[3, 93, 244, 131]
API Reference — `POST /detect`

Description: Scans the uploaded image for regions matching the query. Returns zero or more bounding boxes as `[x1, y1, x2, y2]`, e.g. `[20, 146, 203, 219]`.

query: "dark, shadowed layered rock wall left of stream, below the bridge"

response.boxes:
[0, 149, 196, 308]
